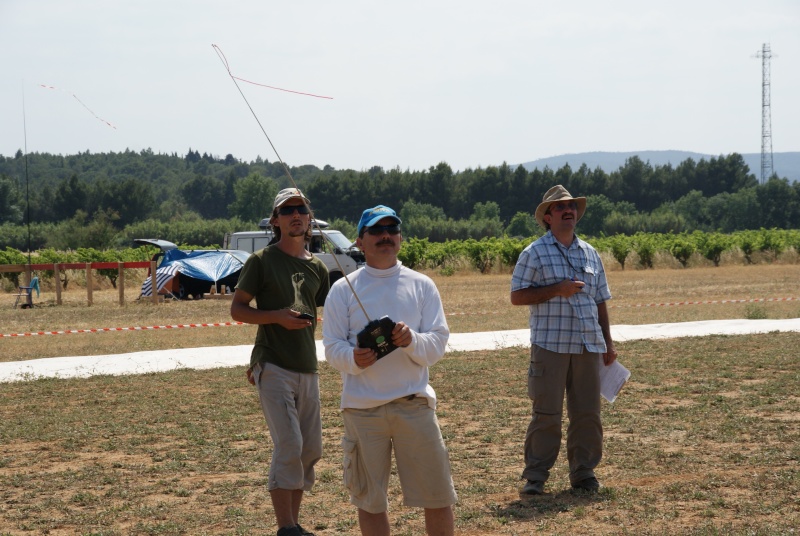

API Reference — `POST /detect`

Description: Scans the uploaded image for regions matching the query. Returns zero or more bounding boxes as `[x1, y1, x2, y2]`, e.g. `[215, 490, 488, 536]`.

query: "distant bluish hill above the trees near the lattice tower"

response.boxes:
[520, 151, 800, 181]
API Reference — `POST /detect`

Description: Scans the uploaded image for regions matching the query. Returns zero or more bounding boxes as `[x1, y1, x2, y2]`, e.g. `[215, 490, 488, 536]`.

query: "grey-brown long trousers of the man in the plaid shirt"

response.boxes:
[522, 345, 603, 484]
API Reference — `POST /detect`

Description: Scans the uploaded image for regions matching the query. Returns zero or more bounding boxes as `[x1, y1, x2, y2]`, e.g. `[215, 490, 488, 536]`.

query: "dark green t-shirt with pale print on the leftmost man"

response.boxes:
[236, 245, 330, 372]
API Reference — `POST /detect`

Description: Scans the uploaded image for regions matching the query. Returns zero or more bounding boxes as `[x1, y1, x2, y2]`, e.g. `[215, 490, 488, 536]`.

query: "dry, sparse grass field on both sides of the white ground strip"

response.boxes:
[0, 265, 800, 536]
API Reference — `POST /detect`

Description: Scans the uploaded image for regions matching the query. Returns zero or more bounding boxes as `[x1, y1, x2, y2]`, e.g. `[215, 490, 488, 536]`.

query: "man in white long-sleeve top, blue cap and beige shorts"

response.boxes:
[322, 205, 458, 536]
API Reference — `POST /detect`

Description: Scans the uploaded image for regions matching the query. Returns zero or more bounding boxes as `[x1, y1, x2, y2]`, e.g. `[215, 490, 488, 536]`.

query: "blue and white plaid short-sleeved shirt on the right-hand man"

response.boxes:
[511, 231, 611, 354]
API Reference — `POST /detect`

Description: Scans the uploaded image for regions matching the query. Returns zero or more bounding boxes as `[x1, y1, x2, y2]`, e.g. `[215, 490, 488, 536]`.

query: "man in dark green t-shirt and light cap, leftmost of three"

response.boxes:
[231, 188, 330, 536]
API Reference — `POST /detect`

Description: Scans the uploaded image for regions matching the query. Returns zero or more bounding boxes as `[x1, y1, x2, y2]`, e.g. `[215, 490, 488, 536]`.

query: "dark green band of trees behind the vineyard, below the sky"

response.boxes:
[0, 149, 800, 249]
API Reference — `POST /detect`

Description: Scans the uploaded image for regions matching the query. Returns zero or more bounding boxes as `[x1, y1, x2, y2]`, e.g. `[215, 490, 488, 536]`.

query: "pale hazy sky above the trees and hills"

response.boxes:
[0, 0, 800, 170]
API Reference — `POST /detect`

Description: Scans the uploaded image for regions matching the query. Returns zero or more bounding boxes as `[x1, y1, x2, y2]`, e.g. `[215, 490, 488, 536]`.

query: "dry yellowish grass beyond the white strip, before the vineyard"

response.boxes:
[0, 264, 800, 361]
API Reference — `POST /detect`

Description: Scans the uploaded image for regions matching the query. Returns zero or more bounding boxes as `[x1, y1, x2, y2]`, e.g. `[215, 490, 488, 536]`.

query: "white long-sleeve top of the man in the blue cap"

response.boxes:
[322, 261, 450, 409]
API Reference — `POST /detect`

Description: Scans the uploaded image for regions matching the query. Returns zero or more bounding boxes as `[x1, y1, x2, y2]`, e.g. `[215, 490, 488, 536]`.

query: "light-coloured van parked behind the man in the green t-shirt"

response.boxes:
[222, 218, 365, 285]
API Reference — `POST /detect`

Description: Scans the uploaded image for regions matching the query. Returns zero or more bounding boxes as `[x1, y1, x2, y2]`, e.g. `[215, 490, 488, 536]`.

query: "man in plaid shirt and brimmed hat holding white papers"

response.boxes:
[511, 185, 617, 495]
